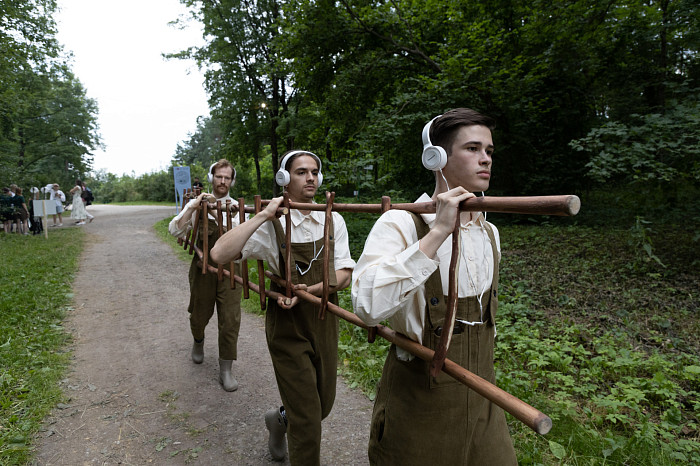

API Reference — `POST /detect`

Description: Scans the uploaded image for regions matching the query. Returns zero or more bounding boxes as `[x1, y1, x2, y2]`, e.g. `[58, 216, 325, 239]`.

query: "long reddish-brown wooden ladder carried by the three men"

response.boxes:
[179, 188, 581, 435]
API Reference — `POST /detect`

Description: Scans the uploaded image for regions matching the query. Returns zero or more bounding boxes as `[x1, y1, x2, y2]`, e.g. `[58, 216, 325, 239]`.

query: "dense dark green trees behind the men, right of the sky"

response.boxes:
[171, 0, 700, 204]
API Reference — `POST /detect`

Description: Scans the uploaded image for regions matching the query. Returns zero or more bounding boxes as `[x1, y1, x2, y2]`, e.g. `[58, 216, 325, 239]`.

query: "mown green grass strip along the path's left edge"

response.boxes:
[0, 228, 84, 464]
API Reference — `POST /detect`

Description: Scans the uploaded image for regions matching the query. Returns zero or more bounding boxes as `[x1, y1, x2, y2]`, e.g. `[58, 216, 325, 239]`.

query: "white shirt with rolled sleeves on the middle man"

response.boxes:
[241, 209, 355, 275]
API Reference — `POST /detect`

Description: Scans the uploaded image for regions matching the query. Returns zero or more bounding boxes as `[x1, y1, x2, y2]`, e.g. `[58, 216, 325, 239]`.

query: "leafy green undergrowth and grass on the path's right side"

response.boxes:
[152, 215, 700, 465]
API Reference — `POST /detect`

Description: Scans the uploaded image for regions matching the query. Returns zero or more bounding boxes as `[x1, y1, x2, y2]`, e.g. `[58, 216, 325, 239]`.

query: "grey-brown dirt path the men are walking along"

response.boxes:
[36, 206, 371, 466]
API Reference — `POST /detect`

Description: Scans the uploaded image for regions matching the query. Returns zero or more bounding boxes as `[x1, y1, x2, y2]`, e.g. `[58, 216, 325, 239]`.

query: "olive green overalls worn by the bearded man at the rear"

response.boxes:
[187, 219, 242, 360]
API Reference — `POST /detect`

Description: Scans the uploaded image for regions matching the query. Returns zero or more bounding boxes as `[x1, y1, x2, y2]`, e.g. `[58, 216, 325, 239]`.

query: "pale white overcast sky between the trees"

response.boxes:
[56, 0, 209, 175]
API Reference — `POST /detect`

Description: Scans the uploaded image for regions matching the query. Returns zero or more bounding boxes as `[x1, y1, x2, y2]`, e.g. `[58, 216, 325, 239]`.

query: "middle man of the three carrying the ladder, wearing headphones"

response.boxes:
[211, 150, 355, 465]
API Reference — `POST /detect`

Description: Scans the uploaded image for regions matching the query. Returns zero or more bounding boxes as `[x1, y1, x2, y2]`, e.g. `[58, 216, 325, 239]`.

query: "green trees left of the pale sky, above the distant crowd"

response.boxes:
[0, 0, 100, 191]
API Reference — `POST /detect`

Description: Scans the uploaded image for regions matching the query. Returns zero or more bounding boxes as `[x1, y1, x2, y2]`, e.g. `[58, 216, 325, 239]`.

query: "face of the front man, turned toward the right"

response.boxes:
[438, 125, 493, 192]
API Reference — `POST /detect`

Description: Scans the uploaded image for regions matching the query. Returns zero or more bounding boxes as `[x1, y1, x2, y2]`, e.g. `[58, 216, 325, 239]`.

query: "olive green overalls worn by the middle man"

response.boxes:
[265, 219, 338, 466]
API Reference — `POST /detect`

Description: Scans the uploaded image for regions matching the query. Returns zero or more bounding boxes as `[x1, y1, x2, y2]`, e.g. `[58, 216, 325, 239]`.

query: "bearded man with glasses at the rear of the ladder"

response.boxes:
[168, 159, 241, 392]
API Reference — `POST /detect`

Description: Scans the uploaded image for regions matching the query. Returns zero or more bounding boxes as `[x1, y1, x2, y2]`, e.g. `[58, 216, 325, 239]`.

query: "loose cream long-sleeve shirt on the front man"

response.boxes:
[352, 194, 500, 360]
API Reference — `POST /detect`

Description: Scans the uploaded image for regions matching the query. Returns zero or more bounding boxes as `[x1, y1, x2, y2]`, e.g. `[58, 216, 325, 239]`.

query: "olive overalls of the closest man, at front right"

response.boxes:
[369, 214, 517, 466]
